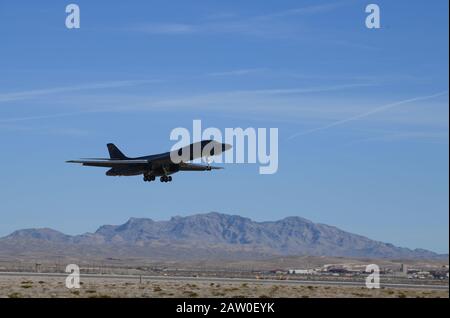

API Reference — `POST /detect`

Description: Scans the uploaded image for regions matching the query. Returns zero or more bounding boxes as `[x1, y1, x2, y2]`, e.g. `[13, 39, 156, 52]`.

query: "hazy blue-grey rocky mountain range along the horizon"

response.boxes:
[0, 212, 448, 260]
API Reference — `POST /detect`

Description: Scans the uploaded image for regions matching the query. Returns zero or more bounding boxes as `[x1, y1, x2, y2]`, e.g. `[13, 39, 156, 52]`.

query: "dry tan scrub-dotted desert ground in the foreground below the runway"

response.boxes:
[0, 276, 449, 298]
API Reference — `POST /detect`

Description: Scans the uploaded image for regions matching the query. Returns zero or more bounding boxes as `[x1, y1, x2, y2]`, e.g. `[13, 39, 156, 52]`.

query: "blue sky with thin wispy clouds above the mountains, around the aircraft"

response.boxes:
[0, 0, 449, 253]
